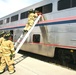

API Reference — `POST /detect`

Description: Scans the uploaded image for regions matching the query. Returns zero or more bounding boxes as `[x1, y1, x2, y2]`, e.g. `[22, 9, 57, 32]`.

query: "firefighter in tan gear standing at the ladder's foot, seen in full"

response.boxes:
[0, 33, 15, 74]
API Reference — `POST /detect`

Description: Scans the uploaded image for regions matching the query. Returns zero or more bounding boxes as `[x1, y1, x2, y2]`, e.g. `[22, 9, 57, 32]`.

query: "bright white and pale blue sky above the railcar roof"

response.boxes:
[0, 0, 42, 18]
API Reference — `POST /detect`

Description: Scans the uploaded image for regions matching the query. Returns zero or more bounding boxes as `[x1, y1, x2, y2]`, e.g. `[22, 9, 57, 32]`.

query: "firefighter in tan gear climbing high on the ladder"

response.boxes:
[24, 9, 38, 32]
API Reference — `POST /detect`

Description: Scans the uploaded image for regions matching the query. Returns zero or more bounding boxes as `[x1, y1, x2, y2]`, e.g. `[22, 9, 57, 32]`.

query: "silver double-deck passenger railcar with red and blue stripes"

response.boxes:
[0, 0, 76, 63]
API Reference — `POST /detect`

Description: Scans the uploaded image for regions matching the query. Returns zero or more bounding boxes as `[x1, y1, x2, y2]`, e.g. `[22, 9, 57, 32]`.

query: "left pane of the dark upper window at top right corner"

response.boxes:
[58, 0, 71, 10]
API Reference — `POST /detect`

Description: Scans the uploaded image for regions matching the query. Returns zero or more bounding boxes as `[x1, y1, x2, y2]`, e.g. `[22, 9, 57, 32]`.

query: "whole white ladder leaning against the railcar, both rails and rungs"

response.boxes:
[14, 15, 41, 53]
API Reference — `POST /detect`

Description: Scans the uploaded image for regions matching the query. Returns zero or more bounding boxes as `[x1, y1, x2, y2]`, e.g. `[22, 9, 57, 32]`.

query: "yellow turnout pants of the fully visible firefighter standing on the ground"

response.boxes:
[0, 56, 14, 72]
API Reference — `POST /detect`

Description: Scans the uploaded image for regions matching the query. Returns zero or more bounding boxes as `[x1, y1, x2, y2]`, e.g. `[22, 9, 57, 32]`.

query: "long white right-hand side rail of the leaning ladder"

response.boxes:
[15, 15, 41, 53]
